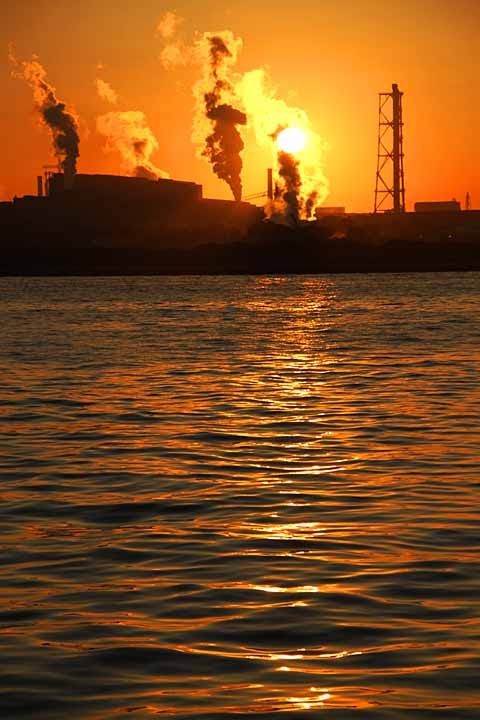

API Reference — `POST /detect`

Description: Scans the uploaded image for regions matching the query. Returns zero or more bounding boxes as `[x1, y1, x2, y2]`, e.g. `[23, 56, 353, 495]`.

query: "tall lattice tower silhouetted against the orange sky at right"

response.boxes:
[374, 84, 405, 213]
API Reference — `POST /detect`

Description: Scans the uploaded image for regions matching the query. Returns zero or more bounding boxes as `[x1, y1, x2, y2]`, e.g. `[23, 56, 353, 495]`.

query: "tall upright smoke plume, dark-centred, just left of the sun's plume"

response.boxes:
[193, 30, 247, 200]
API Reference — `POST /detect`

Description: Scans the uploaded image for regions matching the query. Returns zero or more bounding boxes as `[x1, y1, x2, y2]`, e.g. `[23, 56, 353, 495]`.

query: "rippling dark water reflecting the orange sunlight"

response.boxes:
[0, 274, 480, 720]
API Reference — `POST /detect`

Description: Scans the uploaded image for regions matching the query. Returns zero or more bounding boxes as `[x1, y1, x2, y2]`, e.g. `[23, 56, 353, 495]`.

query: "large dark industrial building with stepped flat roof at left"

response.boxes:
[0, 170, 263, 247]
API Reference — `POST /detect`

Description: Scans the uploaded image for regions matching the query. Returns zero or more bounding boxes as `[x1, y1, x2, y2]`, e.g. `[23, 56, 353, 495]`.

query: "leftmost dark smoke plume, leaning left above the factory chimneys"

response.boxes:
[14, 59, 80, 179]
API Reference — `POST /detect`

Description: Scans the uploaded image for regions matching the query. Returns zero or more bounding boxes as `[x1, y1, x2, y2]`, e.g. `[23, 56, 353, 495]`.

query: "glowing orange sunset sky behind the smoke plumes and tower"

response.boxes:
[0, 0, 480, 211]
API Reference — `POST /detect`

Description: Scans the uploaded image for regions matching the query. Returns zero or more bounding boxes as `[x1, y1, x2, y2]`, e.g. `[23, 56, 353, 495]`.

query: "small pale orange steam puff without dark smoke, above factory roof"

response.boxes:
[97, 110, 169, 180]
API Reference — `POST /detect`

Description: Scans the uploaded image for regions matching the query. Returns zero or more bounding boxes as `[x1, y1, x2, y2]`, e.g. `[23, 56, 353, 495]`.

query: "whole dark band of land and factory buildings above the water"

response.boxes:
[0, 175, 480, 275]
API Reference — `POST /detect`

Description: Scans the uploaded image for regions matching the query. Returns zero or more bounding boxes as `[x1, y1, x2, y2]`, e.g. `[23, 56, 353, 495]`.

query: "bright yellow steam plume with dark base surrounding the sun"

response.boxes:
[235, 68, 329, 220]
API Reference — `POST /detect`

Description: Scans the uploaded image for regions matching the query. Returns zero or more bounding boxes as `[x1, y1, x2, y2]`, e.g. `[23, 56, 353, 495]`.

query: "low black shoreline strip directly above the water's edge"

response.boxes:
[0, 228, 480, 275]
